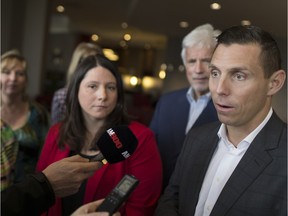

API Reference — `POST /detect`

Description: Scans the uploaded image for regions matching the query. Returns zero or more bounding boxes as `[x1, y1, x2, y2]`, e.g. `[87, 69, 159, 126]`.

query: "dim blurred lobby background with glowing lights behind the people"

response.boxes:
[1, 0, 287, 124]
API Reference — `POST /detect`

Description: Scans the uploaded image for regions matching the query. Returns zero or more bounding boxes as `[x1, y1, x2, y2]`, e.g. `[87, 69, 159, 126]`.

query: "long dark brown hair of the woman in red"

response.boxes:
[58, 54, 130, 152]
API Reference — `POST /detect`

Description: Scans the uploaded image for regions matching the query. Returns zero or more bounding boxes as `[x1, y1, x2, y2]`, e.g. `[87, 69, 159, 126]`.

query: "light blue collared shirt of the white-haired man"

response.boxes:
[185, 87, 211, 134]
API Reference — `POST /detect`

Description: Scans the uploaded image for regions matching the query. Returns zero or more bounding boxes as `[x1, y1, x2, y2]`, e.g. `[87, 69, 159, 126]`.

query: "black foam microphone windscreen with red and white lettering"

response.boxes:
[97, 125, 138, 164]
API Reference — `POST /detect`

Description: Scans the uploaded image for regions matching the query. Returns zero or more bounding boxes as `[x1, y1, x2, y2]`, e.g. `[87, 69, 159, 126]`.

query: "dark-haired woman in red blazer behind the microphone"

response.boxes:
[37, 55, 162, 216]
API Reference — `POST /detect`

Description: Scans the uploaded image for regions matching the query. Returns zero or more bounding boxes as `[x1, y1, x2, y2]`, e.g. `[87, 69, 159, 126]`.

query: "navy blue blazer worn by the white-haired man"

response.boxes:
[150, 88, 218, 188]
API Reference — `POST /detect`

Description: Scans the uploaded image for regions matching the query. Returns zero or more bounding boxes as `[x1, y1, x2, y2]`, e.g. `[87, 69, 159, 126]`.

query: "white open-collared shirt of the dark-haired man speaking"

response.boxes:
[194, 108, 273, 216]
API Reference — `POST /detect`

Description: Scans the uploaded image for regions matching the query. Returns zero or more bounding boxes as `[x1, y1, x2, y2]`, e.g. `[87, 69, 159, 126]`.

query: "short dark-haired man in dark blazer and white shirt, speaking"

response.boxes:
[156, 26, 287, 216]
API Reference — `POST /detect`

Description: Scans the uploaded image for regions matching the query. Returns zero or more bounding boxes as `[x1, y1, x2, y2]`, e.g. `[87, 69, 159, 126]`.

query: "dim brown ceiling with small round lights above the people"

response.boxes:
[51, 0, 287, 48]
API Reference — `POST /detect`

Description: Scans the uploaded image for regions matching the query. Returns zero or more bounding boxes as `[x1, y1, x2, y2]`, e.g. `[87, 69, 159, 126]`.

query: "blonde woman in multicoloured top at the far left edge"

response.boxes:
[0, 50, 50, 191]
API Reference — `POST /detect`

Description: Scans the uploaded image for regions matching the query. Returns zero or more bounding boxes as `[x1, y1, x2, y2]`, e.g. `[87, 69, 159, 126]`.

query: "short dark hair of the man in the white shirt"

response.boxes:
[216, 26, 281, 78]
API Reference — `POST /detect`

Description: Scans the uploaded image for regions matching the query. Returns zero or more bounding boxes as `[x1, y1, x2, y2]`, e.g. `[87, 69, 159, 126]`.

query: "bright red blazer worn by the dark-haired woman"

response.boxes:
[37, 122, 162, 216]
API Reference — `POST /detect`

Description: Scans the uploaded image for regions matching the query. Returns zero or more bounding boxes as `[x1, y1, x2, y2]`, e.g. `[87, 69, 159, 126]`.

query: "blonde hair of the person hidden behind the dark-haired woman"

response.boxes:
[66, 42, 103, 86]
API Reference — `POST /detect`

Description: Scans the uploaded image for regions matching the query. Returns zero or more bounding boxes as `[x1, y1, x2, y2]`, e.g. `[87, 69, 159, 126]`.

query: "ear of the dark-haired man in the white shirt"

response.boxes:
[267, 70, 286, 95]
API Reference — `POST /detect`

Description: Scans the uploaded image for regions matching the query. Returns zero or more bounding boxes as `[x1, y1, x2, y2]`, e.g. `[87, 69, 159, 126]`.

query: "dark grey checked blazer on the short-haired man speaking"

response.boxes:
[155, 113, 287, 216]
